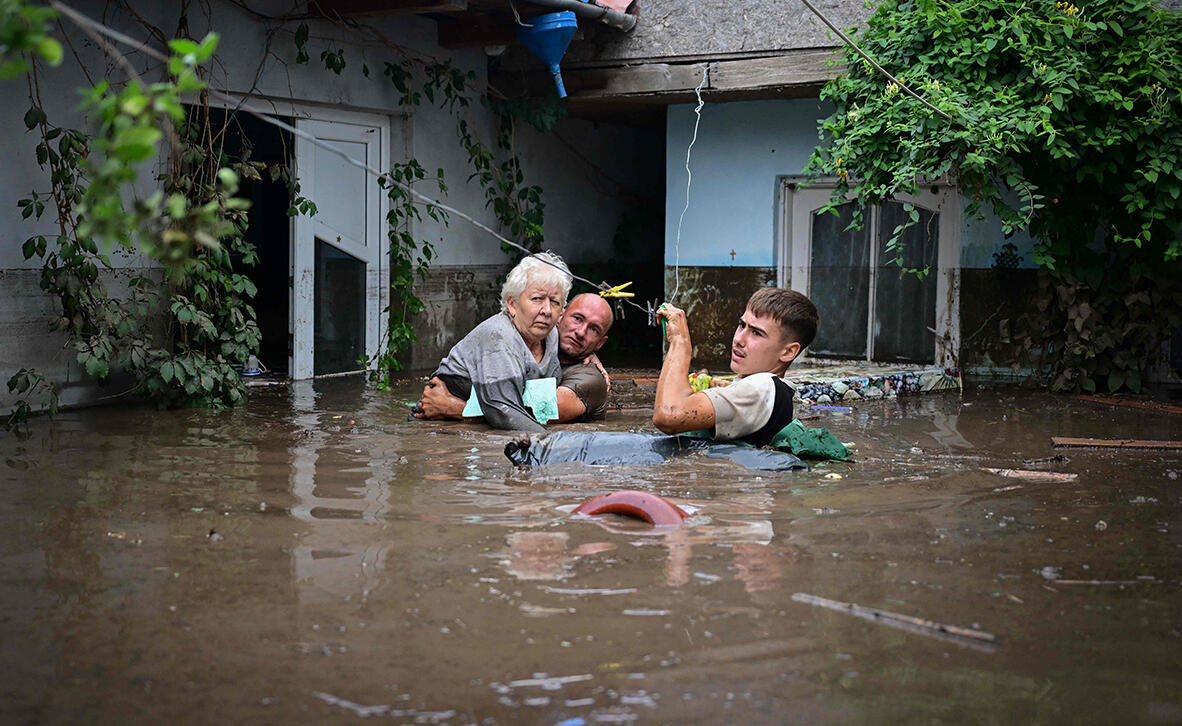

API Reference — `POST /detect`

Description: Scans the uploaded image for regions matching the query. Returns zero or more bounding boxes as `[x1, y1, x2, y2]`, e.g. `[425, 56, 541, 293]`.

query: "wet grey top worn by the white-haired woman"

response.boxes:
[433, 312, 563, 433]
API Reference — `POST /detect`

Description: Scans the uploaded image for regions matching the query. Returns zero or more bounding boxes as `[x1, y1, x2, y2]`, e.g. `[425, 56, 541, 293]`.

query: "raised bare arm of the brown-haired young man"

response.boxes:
[652, 303, 714, 434]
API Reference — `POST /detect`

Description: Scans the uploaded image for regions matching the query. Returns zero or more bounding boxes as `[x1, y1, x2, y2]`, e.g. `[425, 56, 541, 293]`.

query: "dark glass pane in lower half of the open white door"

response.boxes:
[312, 239, 365, 376]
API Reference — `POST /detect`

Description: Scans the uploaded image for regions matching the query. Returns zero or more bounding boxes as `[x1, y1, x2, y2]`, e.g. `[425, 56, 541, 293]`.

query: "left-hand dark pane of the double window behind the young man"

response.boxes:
[808, 202, 870, 358]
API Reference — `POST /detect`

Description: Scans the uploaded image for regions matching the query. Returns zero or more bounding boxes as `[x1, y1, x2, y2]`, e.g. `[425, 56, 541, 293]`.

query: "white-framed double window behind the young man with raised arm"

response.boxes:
[780, 181, 960, 365]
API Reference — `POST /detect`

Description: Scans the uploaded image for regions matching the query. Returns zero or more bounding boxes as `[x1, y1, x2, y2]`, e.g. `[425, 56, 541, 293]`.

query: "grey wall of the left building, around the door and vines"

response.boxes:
[0, 0, 663, 409]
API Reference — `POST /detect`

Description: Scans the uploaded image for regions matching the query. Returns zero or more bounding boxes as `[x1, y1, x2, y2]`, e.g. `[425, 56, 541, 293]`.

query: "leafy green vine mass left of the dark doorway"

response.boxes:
[7, 17, 268, 428]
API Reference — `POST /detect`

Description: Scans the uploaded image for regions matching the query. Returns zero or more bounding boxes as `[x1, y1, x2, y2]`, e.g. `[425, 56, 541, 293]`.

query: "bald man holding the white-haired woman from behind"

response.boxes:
[415, 292, 613, 423]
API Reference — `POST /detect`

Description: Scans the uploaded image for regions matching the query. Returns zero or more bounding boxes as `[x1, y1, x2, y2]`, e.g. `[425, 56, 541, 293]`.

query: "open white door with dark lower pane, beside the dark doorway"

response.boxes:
[290, 117, 389, 380]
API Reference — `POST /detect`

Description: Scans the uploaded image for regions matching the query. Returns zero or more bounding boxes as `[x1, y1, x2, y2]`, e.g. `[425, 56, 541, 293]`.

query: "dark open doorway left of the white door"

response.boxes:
[196, 109, 294, 377]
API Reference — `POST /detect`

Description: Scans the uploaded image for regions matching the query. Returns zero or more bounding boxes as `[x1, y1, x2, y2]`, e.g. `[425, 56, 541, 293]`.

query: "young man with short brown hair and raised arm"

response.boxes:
[652, 287, 818, 446]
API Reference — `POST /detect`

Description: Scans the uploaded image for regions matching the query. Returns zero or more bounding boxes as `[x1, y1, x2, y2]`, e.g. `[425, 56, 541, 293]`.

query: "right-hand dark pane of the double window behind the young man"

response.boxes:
[875, 202, 940, 363]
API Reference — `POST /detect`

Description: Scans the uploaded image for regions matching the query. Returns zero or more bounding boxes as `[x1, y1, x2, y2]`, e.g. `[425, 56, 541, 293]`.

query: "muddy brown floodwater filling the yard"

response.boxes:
[0, 381, 1182, 726]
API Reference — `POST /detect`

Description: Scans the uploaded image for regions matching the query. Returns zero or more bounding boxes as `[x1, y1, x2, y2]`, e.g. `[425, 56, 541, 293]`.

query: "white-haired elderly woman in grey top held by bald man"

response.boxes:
[416, 252, 571, 432]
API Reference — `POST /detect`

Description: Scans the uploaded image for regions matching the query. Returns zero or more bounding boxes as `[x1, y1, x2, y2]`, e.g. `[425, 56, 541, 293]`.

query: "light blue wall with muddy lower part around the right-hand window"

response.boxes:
[664, 99, 1032, 370]
